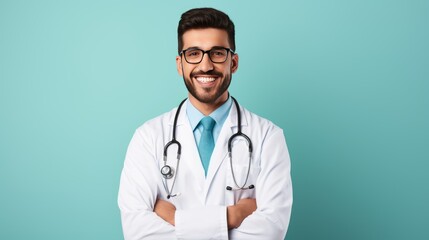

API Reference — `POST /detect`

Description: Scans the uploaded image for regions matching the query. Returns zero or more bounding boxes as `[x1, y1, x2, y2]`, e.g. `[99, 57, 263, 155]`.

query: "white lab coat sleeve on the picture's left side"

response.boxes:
[118, 129, 176, 240]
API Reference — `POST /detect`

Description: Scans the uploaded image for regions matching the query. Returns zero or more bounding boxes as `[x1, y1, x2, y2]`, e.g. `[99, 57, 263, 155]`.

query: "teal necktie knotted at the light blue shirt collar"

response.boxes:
[198, 117, 216, 176]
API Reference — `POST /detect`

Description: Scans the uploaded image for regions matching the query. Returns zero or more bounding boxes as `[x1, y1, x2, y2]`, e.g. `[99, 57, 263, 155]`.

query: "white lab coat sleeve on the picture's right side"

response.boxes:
[229, 128, 292, 240]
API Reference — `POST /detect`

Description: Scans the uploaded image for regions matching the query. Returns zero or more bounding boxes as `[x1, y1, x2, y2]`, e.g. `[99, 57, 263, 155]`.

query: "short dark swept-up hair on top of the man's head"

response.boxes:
[177, 8, 235, 53]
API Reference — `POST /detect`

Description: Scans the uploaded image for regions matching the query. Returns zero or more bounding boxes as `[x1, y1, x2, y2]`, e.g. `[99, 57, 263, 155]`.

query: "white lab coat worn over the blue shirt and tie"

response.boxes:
[118, 101, 292, 240]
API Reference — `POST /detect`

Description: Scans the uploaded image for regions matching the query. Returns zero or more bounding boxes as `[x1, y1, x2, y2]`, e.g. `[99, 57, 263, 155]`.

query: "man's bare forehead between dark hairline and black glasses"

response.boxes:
[182, 28, 230, 50]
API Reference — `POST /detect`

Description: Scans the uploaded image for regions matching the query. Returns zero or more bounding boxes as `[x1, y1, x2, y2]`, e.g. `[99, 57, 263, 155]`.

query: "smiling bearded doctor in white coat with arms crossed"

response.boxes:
[118, 8, 292, 240]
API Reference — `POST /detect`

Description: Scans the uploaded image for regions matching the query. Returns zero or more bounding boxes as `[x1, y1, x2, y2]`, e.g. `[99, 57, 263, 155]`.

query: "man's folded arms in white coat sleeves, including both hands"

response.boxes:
[118, 124, 292, 240]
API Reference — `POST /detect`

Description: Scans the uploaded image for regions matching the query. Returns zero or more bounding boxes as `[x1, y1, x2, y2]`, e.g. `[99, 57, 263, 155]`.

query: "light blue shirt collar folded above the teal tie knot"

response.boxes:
[186, 96, 232, 131]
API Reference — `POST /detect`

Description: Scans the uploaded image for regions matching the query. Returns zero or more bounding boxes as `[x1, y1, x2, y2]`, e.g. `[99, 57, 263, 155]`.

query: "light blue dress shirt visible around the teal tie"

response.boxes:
[186, 96, 232, 146]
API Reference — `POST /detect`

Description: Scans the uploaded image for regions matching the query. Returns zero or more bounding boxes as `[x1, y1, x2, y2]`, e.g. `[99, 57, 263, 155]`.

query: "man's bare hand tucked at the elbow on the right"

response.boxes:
[227, 198, 256, 229]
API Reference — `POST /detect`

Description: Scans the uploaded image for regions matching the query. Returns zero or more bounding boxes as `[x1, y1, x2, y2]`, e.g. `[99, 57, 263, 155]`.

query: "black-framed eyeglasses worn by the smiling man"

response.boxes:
[179, 47, 235, 64]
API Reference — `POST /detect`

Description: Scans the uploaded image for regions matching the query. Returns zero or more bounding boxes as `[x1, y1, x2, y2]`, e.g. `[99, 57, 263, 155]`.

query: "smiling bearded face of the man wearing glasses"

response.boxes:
[176, 28, 238, 106]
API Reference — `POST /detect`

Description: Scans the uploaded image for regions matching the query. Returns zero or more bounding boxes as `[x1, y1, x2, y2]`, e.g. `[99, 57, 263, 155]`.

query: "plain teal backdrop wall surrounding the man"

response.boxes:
[0, 0, 429, 240]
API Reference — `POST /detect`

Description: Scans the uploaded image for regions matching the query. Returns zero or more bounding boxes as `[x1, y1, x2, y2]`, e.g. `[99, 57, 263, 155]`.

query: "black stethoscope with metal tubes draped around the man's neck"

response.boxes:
[161, 96, 255, 199]
